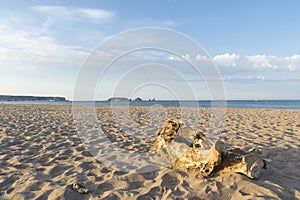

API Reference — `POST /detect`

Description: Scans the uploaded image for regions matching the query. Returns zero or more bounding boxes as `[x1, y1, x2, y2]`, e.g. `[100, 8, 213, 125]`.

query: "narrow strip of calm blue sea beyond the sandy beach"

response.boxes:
[0, 100, 300, 109]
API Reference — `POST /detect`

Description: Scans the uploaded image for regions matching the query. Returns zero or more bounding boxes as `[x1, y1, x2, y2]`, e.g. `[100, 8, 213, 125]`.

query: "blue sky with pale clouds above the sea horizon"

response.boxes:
[0, 0, 300, 100]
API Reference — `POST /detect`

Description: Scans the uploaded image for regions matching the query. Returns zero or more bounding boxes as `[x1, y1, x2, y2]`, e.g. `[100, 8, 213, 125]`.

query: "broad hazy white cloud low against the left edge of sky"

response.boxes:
[0, 23, 88, 71]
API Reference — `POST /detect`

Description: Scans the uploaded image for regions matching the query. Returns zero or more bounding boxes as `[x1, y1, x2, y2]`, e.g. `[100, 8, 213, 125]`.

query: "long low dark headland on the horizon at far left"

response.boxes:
[0, 95, 68, 101]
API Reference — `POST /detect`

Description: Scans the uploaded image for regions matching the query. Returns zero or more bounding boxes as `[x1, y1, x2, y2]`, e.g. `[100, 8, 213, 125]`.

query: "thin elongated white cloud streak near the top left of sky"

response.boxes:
[32, 5, 115, 22]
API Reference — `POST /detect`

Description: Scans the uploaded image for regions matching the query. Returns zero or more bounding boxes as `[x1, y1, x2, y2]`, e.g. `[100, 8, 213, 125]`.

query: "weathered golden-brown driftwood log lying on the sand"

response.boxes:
[151, 120, 266, 179]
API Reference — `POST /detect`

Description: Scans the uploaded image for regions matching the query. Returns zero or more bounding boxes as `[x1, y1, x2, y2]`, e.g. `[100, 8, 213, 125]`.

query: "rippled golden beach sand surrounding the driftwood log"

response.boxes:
[0, 104, 300, 200]
